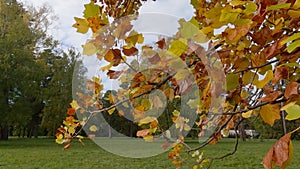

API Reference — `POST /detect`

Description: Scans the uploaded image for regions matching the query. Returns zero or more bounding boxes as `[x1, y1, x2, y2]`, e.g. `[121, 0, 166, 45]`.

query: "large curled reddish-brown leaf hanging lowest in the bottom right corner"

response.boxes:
[262, 133, 292, 169]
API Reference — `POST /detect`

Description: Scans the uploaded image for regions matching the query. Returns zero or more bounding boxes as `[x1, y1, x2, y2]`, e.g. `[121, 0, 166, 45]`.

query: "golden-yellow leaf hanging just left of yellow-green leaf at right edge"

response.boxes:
[259, 104, 280, 126]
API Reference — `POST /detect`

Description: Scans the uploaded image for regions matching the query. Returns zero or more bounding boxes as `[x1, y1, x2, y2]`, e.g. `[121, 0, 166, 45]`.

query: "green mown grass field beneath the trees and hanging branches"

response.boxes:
[0, 138, 300, 169]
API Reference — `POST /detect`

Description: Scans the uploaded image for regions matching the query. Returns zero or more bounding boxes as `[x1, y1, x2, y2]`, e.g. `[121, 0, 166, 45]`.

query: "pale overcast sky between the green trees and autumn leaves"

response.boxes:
[19, 0, 194, 89]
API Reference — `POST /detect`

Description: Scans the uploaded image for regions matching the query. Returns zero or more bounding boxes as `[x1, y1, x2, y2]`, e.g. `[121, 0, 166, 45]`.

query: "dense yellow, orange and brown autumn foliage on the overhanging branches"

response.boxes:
[57, 0, 300, 168]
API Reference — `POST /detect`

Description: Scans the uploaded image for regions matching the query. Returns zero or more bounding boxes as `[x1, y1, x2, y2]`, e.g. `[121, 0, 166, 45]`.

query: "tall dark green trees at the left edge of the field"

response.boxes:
[0, 0, 85, 140]
